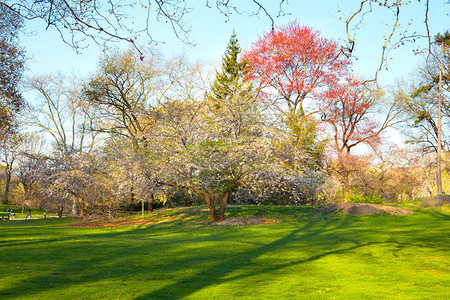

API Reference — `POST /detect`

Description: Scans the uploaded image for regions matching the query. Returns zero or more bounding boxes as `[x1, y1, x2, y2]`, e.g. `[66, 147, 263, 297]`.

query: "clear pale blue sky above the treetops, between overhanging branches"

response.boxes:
[21, 0, 450, 84]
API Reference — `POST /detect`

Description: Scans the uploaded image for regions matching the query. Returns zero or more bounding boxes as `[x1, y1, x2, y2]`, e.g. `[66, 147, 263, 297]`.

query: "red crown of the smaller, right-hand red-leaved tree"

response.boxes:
[323, 77, 381, 154]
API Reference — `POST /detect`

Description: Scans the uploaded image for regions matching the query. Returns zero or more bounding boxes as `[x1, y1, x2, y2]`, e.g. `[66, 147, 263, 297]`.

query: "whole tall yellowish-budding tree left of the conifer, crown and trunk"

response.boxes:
[84, 49, 198, 216]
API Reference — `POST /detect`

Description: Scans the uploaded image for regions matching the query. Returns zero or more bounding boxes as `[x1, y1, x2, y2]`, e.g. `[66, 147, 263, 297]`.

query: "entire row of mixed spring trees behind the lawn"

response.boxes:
[0, 5, 449, 221]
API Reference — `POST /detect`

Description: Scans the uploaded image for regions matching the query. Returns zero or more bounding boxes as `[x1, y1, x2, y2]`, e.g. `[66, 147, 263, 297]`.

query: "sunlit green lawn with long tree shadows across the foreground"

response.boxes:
[0, 207, 450, 299]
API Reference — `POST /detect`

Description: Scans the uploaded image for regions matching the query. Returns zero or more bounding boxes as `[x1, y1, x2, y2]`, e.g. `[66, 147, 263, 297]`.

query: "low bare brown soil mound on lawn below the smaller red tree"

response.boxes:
[325, 203, 414, 216]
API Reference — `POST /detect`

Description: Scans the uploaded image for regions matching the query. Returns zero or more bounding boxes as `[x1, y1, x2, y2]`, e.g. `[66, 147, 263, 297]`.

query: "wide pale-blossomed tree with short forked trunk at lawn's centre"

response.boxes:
[152, 97, 270, 221]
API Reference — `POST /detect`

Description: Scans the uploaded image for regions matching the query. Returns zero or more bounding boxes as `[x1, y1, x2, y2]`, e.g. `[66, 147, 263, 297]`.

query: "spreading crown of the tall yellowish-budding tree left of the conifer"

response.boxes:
[84, 49, 165, 147]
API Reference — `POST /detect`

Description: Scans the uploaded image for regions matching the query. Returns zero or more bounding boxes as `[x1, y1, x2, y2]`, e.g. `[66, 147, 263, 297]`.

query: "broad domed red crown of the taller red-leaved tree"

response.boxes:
[243, 22, 350, 114]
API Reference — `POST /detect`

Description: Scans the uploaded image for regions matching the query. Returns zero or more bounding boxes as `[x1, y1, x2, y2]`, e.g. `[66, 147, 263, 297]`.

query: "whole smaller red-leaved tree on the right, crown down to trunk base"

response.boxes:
[322, 76, 395, 193]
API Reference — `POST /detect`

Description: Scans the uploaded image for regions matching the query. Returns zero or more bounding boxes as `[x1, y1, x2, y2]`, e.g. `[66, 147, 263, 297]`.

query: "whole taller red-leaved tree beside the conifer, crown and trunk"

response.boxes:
[243, 22, 350, 169]
